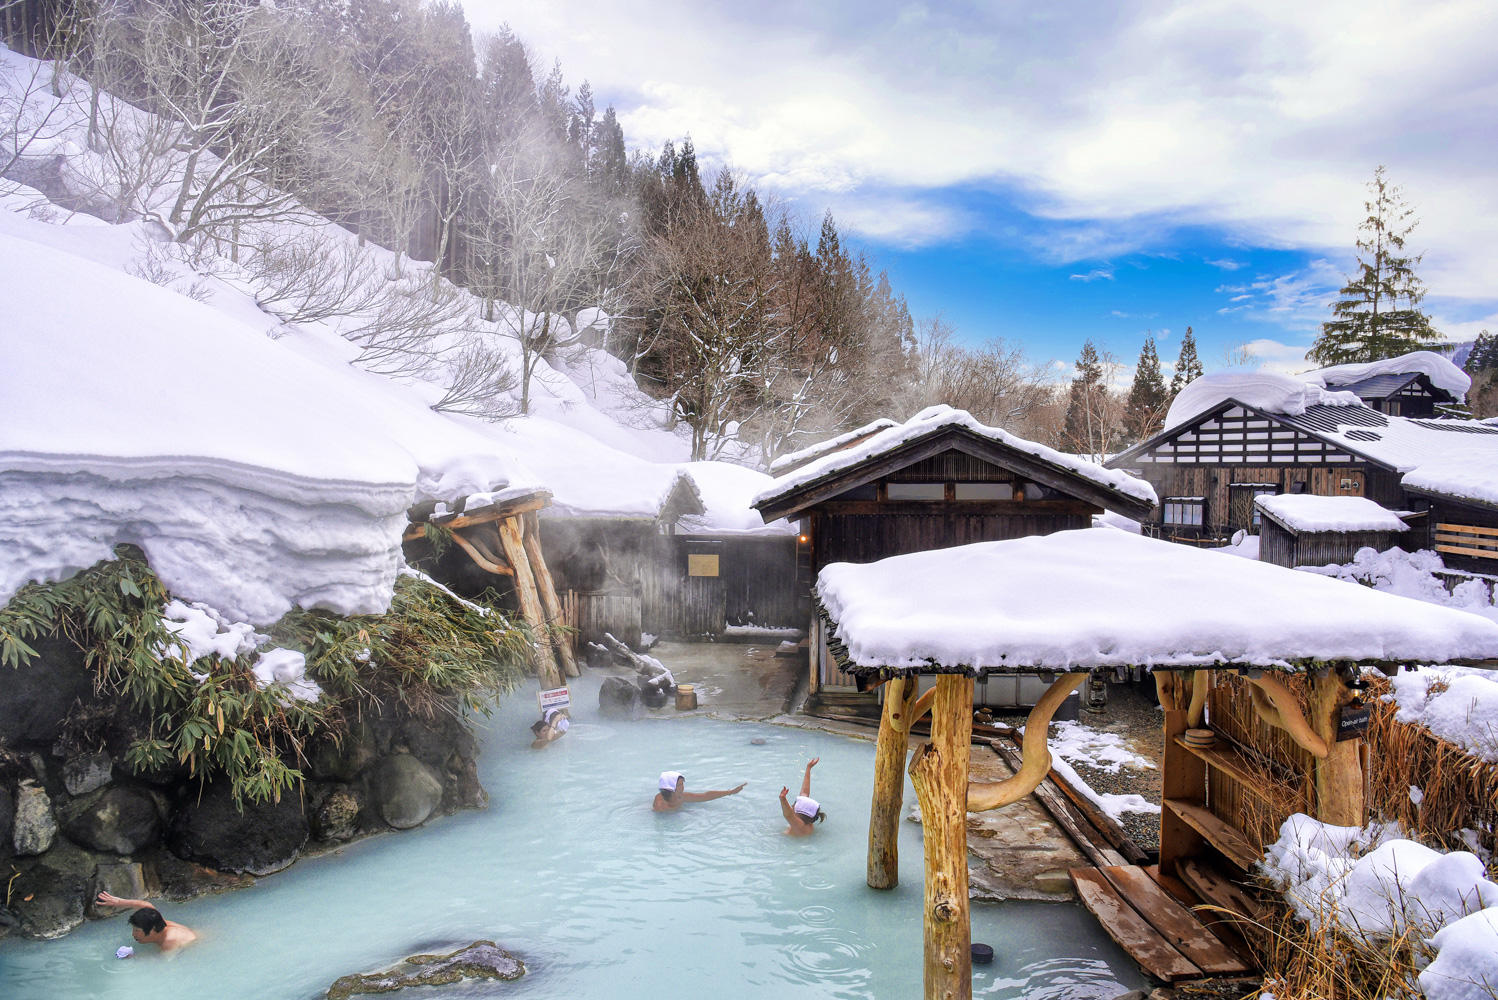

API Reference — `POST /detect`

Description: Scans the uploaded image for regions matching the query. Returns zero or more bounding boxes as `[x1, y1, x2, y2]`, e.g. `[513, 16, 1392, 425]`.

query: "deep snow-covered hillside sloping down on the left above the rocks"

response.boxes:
[0, 46, 791, 623]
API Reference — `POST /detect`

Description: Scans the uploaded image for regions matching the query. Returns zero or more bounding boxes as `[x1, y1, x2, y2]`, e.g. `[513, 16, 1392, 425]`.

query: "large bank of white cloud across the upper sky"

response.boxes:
[466, 0, 1498, 301]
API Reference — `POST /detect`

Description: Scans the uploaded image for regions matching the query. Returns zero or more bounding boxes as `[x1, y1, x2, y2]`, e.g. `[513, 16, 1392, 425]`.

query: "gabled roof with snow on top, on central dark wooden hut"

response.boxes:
[753, 406, 1156, 519]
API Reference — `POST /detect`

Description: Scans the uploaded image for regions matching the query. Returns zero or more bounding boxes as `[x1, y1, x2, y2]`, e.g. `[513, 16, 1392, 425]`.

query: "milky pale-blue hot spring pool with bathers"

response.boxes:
[0, 678, 1143, 1000]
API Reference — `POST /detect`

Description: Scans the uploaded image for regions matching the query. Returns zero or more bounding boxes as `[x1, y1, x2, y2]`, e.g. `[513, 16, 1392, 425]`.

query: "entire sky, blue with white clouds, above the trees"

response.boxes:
[464, 0, 1498, 378]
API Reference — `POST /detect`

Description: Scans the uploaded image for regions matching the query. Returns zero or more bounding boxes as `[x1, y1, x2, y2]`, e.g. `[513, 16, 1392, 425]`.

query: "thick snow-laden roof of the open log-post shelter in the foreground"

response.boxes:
[816, 528, 1498, 674]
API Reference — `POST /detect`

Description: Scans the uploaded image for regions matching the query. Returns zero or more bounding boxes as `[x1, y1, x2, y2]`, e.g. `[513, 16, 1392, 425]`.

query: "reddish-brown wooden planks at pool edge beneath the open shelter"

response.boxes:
[1071, 862, 1254, 982]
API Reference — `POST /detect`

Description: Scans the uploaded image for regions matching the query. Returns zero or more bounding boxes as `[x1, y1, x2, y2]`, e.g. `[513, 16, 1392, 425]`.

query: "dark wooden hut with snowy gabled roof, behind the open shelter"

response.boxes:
[755, 407, 1152, 693]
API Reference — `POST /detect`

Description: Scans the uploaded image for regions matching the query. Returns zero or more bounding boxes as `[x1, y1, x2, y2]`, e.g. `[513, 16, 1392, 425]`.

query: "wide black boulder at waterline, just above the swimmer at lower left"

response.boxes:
[166, 781, 309, 876]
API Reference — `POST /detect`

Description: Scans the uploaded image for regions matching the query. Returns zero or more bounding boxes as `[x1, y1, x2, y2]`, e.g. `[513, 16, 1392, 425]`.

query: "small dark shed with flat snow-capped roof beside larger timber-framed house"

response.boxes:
[1255, 494, 1411, 569]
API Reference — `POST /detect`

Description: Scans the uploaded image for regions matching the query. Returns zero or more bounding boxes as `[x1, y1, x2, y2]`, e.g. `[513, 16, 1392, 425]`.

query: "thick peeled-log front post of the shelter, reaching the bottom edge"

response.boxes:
[911, 674, 972, 1000]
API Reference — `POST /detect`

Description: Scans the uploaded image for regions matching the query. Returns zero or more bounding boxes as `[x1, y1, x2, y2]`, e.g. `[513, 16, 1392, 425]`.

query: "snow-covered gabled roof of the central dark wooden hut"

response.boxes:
[753, 406, 1155, 507]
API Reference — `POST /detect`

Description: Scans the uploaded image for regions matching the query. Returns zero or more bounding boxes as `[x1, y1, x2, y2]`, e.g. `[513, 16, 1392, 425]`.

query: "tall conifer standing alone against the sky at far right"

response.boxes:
[1306, 166, 1441, 367]
